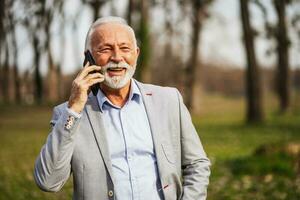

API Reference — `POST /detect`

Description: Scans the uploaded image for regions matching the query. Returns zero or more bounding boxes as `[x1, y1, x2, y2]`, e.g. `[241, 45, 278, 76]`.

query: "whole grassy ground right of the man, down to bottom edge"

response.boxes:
[198, 93, 300, 200]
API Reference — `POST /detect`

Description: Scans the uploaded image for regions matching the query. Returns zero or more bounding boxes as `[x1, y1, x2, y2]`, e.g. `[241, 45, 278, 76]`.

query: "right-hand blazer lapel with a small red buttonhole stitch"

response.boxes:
[136, 81, 166, 179]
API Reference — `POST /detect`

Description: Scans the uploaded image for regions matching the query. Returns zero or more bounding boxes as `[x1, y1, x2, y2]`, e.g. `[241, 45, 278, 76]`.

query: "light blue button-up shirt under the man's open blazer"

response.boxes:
[97, 79, 163, 200]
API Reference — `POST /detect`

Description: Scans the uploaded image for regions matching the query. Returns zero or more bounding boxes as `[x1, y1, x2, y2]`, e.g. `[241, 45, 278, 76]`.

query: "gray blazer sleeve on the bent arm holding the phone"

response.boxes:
[34, 106, 80, 192]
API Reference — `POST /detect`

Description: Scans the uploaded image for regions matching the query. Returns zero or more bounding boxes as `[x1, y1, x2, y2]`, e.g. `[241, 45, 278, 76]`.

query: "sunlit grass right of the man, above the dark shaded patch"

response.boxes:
[193, 93, 300, 160]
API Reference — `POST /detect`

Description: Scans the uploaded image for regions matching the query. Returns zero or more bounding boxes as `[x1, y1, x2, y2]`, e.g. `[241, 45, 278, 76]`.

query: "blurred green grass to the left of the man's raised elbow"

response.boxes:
[0, 106, 71, 200]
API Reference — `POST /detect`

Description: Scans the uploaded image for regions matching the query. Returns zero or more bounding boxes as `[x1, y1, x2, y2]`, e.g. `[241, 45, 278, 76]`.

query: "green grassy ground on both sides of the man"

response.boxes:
[0, 95, 300, 200]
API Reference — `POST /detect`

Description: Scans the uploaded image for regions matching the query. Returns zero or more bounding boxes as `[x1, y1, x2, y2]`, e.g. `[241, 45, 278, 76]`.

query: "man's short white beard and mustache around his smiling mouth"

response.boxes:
[101, 62, 136, 89]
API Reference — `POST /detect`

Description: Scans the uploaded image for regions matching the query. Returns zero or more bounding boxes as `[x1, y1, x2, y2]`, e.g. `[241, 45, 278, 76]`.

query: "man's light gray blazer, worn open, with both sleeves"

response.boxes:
[34, 82, 210, 200]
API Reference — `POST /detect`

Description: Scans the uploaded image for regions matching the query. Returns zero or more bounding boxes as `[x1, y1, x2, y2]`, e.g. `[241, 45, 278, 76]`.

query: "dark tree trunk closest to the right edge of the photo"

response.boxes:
[273, 0, 290, 112]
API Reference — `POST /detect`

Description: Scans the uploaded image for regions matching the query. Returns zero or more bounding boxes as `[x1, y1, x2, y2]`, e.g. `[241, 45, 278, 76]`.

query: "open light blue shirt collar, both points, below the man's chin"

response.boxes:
[97, 79, 141, 112]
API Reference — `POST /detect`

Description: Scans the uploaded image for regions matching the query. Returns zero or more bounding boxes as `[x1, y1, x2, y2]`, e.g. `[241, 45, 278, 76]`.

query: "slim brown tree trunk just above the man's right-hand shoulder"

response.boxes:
[184, 1, 202, 109]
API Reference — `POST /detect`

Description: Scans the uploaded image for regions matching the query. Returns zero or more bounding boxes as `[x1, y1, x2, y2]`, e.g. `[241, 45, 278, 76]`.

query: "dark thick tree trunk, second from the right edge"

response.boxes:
[240, 0, 263, 122]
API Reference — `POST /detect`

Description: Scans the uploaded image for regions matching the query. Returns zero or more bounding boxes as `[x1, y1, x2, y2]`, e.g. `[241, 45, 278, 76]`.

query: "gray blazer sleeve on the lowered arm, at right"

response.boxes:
[177, 90, 210, 200]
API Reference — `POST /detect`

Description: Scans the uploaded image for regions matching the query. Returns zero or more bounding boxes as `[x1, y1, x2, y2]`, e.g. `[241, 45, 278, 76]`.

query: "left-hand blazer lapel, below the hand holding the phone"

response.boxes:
[85, 93, 113, 183]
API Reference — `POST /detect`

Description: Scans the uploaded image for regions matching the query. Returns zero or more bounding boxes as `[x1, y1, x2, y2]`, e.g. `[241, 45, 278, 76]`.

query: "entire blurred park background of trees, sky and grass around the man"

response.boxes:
[0, 0, 300, 200]
